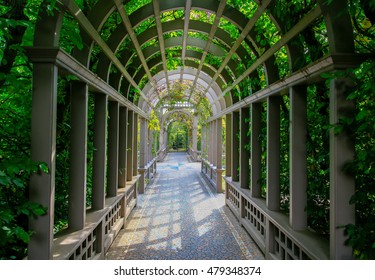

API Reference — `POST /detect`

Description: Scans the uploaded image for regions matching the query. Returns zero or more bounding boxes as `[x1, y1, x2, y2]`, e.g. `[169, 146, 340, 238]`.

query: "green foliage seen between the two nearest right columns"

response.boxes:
[306, 85, 330, 237]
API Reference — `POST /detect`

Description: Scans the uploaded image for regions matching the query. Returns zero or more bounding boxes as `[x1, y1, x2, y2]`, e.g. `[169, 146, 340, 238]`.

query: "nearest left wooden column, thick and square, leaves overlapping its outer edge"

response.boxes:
[28, 63, 58, 260]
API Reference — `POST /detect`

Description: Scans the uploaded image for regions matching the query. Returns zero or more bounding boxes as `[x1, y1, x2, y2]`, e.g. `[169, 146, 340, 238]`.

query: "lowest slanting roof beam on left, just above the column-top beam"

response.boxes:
[64, 1, 151, 104]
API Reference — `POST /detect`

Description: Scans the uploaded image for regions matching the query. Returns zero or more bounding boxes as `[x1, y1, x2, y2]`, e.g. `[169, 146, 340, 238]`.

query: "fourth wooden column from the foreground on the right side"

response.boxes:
[250, 103, 262, 197]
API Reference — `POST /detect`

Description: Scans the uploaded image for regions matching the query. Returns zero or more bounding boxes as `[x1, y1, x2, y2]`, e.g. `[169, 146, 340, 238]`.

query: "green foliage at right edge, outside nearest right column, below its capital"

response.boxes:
[341, 61, 375, 259]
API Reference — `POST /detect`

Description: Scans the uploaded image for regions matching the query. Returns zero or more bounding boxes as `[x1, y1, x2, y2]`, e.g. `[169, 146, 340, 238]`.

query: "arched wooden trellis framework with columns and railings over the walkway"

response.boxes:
[28, 0, 368, 259]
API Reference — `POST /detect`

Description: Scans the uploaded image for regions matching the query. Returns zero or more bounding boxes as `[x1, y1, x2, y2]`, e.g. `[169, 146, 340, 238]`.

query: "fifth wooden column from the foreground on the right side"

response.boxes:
[240, 107, 250, 189]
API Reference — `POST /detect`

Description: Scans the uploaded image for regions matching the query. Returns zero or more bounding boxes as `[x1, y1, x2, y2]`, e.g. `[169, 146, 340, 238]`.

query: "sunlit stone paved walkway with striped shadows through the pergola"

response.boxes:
[106, 153, 263, 260]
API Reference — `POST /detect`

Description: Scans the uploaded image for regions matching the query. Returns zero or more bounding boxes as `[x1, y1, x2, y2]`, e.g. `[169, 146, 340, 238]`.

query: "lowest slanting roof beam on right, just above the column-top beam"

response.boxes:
[214, 5, 322, 103]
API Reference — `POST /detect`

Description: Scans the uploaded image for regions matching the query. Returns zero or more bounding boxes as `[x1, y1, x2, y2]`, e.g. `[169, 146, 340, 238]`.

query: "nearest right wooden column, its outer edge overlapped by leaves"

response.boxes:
[330, 78, 355, 259]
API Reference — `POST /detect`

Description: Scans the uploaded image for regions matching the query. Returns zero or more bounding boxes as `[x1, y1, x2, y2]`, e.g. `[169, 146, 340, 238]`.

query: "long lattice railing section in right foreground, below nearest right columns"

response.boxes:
[225, 178, 329, 260]
